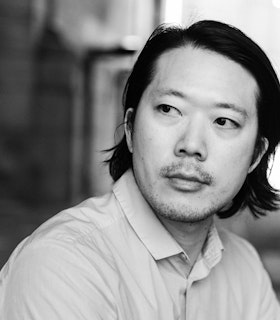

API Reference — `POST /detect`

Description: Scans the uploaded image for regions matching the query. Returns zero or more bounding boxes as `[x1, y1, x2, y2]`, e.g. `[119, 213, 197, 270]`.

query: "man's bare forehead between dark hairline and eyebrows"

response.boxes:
[144, 45, 259, 114]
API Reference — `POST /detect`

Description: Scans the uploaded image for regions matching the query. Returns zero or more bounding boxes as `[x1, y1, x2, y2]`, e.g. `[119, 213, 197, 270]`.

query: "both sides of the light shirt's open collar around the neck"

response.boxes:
[113, 169, 223, 268]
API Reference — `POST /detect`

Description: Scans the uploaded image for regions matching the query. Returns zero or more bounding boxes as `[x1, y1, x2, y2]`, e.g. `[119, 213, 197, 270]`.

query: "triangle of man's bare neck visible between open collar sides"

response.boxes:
[156, 217, 213, 265]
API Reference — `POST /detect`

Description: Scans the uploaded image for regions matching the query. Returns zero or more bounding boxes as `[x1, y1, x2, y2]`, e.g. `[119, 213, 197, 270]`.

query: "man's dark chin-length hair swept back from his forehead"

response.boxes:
[107, 20, 280, 218]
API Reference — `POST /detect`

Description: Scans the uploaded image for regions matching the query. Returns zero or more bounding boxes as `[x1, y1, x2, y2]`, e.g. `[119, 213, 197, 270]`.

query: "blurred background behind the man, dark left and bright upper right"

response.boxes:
[0, 0, 280, 295]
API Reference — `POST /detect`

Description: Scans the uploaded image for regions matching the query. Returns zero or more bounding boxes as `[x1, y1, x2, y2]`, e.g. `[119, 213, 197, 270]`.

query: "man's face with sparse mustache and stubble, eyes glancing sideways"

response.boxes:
[126, 46, 260, 222]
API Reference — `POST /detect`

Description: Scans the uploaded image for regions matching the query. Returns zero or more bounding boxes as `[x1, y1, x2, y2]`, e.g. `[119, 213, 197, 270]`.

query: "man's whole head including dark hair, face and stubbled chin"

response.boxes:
[110, 21, 280, 220]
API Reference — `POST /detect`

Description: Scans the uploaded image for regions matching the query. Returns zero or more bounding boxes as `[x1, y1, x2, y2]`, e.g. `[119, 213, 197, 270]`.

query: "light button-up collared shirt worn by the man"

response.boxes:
[0, 170, 280, 320]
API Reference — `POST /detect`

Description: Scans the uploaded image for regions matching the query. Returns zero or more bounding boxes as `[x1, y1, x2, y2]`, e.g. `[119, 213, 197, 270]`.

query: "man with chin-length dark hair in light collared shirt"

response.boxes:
[1, 21, 280, 320]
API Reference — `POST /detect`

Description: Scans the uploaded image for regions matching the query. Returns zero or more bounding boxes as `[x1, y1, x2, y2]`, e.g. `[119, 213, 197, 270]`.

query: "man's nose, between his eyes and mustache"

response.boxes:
[175, 117, 208, 161]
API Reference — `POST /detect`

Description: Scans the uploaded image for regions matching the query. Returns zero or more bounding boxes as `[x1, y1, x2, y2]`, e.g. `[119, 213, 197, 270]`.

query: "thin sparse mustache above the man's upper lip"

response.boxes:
[159, 162, 214, 184]
